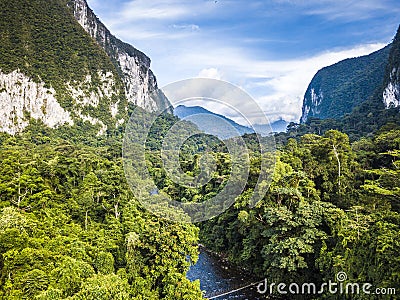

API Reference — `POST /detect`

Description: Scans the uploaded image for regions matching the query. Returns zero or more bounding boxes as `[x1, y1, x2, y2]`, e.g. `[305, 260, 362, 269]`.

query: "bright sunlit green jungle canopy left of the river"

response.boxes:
[0, 116, 202, 300]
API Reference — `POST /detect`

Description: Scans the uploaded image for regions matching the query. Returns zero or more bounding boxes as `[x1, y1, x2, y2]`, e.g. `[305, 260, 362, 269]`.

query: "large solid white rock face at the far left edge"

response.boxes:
[0, 70, 73, 134]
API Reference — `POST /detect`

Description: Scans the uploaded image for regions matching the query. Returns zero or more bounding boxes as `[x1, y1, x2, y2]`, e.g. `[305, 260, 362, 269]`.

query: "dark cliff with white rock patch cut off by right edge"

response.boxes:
[382, 27, 400, 108]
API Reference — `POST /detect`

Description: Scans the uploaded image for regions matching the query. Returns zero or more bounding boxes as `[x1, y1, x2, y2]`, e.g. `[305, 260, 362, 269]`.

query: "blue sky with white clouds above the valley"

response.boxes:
[87, 0, 400, 123]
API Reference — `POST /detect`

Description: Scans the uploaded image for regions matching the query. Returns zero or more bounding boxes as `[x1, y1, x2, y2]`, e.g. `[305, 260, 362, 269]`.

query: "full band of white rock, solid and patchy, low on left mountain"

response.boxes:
[0, 70, 123, 134]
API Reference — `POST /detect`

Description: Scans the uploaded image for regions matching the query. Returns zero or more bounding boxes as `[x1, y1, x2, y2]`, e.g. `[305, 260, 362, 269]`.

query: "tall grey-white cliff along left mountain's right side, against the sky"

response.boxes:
[68, 0, 170, 111]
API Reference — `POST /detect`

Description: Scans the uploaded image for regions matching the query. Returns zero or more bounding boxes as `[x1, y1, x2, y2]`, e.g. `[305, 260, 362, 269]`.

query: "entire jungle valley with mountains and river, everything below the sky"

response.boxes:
[0, 0, 400, 300]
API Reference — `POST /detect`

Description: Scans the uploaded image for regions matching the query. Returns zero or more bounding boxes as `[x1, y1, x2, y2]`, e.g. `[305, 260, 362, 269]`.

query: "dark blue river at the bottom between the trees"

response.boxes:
[187, 249, 266, 300]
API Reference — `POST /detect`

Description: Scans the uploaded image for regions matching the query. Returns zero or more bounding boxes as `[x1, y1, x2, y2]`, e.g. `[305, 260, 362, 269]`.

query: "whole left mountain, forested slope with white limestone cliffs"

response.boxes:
[0, 0, 169, 134]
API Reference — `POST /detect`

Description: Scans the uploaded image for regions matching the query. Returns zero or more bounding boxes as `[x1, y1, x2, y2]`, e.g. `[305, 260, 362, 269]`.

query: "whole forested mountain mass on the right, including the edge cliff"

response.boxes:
[288, 29, 400, 141]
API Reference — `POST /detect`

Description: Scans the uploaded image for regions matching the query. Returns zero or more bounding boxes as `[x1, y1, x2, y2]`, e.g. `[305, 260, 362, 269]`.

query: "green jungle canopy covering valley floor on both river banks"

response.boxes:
[0, 108, 400, 299]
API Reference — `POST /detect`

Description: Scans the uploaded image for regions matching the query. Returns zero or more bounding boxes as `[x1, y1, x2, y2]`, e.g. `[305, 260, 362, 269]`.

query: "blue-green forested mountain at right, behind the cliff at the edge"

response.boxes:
[300, 45, 390, 123]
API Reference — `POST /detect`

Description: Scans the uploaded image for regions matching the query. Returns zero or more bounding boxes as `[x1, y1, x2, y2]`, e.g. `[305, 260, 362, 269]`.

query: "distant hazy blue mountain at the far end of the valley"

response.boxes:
[174, 105, 287, 139]
